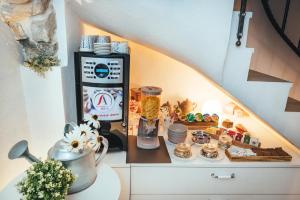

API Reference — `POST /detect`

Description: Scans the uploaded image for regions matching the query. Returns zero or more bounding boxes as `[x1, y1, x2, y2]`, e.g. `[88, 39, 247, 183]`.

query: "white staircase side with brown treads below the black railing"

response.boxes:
[222, 11, 300, 146]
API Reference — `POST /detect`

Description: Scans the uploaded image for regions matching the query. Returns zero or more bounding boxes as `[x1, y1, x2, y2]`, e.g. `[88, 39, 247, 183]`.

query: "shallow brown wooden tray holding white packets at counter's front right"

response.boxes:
[225, 147, 292, 162]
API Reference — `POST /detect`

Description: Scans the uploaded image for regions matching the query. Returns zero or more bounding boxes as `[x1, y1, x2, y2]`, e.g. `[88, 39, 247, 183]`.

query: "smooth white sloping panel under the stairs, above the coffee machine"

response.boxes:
[68, 0, 233, 83]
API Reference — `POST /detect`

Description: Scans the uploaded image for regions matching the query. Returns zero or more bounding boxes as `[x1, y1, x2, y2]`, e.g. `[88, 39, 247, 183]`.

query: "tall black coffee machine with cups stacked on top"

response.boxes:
[75, 52, 130, 151]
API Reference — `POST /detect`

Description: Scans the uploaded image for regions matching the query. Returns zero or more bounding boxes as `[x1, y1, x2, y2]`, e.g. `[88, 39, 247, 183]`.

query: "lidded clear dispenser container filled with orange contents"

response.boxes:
[141, 86, 162, 121]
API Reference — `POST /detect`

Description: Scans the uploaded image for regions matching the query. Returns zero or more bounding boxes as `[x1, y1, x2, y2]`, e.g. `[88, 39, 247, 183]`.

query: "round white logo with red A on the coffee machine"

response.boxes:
[93, 91, 114, 110]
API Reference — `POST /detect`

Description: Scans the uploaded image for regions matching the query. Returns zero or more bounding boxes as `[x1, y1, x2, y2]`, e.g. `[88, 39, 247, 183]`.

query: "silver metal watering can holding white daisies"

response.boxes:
[8, 123, 108, 194]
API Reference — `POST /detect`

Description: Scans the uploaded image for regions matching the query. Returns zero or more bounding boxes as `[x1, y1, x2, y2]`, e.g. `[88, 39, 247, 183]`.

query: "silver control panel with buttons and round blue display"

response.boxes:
[81, 57, 123, 84]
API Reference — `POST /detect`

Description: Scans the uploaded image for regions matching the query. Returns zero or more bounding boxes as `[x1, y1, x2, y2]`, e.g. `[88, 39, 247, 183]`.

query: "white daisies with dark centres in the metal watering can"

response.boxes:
[64, 116, 103, 153]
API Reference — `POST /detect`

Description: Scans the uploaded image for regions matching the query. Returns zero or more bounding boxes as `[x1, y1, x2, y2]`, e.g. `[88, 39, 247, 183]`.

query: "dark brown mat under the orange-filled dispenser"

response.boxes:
[126, 135, 171, 163]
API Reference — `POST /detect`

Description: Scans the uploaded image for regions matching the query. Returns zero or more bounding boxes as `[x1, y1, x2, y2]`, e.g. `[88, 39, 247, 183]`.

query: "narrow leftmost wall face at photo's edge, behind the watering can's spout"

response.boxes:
[0, 21, 30, 190]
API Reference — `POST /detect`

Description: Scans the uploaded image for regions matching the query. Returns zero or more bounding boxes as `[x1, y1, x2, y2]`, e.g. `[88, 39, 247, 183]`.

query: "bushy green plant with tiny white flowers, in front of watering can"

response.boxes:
[17, 160, 75, 200]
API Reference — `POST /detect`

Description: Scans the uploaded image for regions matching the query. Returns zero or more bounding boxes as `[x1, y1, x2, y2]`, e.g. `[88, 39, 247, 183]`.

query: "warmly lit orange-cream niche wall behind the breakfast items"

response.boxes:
[82, 24, 231, 111]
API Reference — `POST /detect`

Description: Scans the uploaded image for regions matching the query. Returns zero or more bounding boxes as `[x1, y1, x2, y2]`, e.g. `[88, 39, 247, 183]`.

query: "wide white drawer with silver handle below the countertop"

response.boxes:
[131, 167, 300, 195]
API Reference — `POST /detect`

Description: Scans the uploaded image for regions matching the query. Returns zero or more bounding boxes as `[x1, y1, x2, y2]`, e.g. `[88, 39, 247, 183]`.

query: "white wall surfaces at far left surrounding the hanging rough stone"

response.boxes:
[0, 1, 67, 189]
